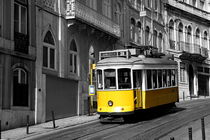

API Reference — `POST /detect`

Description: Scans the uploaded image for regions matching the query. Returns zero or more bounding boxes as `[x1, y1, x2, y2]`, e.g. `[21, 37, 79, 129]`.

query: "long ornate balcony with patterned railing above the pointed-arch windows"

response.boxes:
[66, 0, 120, 38]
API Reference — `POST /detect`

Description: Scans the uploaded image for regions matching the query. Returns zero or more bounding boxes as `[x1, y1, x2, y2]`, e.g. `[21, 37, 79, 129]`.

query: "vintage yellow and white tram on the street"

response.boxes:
[96, 49, 179, 121]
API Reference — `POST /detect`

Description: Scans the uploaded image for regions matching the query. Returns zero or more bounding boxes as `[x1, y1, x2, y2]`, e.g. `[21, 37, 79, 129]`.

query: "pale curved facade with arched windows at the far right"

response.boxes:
[164, 0, 210, 98]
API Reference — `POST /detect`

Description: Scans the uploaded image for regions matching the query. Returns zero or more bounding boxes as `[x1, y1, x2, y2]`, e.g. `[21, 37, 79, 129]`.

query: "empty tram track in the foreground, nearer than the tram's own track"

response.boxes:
[75, 98, 209, 140]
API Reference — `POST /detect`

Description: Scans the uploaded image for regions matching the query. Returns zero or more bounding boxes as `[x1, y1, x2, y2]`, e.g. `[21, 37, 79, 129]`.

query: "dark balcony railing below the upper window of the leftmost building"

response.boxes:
[14, 32, 29, 54]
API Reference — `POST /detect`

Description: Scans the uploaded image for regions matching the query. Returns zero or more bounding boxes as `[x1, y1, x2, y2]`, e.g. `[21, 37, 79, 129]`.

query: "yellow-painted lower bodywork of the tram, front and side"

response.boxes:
[97, 87, 179, 112]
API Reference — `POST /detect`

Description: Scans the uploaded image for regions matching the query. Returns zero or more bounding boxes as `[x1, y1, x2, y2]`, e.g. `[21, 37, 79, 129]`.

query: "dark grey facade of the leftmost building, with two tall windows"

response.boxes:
[0, 0, 36, 129]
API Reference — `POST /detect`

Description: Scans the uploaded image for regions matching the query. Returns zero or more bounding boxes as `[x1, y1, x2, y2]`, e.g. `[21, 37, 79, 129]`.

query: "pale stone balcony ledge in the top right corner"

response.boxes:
[168, 0, 210, 20]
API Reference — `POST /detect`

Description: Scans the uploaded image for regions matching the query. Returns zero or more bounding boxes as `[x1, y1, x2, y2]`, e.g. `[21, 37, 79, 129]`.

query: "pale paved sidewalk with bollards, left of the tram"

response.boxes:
[1, 114, 99, 140]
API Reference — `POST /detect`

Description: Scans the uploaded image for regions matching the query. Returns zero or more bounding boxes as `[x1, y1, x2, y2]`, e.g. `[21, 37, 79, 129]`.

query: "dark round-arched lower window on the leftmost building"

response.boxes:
[12, 68, 29, 107]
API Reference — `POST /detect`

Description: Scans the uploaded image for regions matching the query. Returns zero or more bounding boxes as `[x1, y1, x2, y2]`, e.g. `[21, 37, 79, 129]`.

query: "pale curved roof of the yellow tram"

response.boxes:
[97, 57, 177, 66]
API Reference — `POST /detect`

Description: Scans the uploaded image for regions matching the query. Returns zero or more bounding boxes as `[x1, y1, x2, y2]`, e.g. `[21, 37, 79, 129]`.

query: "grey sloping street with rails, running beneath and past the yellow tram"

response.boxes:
[31, 99, 210, 140]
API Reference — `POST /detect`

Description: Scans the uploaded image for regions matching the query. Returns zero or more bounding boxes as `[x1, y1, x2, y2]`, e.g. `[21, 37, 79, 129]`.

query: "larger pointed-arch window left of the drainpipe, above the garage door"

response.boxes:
[43, 31, 56, 69]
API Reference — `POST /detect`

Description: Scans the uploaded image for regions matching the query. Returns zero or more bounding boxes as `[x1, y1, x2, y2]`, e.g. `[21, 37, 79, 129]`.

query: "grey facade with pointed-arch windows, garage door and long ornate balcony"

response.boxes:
[35, 0, 120, 123]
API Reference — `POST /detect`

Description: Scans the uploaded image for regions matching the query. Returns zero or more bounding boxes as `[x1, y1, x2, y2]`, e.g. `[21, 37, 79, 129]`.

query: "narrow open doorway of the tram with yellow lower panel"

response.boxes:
[133, 70, 142, 108]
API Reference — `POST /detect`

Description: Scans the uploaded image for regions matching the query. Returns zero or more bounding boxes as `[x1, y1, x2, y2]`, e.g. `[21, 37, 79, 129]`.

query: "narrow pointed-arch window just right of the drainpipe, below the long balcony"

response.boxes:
[69, 40, 78, 74]
